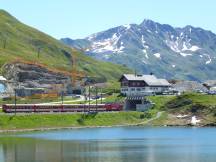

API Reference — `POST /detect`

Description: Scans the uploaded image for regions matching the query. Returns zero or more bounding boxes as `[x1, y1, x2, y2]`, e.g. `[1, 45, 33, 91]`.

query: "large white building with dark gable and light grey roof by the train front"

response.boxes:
[119, 74, 171, 96]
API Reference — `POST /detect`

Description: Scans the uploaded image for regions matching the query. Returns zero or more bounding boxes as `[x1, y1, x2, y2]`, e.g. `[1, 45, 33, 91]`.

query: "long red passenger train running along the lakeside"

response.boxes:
[2, 104, 123, 113]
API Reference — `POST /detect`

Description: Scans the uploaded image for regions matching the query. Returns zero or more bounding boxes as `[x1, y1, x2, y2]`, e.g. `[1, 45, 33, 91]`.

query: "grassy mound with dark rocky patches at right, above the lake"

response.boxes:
[146, 93, 216, 125]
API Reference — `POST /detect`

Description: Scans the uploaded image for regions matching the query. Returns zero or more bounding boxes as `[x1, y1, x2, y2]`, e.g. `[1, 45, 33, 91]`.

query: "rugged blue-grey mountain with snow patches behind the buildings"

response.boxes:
[61, 20, 216, 81]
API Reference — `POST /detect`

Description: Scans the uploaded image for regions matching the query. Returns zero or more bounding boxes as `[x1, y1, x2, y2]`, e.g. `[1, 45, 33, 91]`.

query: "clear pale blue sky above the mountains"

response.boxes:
[0, 0, 216, 39]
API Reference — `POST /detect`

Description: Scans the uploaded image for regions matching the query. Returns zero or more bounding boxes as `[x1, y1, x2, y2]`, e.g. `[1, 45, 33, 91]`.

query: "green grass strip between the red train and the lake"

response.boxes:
[0, 112, 146, 130]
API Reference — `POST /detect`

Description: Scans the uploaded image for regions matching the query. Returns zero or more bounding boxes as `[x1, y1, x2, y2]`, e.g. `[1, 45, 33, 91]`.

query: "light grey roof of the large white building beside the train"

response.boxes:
[123, 74, 170, 86]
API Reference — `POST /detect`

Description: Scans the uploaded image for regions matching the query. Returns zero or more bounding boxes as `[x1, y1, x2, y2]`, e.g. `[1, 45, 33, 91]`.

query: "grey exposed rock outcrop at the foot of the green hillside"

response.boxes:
[3, 63, 71, 96]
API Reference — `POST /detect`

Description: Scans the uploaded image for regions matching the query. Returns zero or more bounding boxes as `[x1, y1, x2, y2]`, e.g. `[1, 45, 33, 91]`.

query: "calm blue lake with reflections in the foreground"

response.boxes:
[0, 127, 216, 162]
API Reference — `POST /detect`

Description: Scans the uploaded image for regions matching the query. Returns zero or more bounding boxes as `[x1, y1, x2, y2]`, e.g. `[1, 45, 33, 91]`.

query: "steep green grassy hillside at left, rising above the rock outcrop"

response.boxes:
[0, 10, 130, 81]
